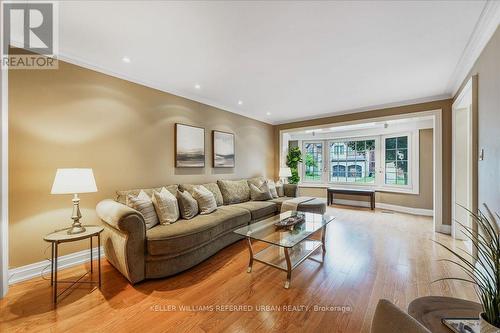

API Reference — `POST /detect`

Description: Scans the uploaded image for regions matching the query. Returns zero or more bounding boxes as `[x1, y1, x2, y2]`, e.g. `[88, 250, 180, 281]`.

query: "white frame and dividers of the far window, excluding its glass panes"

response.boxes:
[299, 129, 420, 194]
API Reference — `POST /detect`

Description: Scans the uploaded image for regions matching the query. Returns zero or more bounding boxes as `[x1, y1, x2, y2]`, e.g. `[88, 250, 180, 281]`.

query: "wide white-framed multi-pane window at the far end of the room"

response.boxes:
[302, 130, 418, 193]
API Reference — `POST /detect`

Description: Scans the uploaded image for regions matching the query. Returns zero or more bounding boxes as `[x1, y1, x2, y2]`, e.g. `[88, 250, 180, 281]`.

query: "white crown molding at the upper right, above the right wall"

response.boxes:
[448, 0, 500, 96]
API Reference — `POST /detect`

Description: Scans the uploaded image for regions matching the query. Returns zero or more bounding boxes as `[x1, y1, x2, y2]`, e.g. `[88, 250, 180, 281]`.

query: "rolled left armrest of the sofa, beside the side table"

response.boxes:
[96, 199, 146, 283]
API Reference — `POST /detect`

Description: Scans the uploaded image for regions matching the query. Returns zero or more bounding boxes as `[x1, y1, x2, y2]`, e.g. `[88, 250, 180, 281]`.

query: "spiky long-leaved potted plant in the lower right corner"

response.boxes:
[436, 204, 500, 333]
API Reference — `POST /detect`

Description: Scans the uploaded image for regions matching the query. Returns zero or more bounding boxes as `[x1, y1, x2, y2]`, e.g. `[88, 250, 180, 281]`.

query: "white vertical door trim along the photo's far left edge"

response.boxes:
[0, 62, 9, 298]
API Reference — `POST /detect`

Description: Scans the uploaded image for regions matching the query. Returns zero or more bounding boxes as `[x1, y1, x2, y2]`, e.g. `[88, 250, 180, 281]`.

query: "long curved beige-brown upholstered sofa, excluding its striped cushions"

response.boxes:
[96, 179, 326, 284]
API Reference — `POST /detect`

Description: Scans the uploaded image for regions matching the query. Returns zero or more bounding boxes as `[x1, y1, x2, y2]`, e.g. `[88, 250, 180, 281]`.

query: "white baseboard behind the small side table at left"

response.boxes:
[9, 246, 104, 285]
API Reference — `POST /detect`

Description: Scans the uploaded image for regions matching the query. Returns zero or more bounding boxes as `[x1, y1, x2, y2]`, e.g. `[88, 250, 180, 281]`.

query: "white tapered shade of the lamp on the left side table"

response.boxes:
[50, 169, 97, 194]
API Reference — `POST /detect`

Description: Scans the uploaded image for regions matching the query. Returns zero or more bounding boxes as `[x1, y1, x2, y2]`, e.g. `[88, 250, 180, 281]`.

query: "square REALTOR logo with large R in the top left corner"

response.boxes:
[2, 1, 58, 69]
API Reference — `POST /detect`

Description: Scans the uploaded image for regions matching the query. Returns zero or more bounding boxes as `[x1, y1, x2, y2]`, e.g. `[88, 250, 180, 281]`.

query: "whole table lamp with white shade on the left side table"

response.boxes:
[50, 169, 97, 235]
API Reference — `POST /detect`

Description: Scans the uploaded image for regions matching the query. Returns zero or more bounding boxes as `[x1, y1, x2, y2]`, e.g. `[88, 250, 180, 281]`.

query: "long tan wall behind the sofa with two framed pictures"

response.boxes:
[9, 62, 274, 268]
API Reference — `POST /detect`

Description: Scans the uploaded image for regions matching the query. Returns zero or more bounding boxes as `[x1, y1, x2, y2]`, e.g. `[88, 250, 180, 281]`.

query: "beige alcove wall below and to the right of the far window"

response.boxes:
[300, 128, 434, 209]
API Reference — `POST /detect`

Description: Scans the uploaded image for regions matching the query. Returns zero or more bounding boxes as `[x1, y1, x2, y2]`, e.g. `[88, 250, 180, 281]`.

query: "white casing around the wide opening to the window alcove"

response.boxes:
[279, 109, 451, 234]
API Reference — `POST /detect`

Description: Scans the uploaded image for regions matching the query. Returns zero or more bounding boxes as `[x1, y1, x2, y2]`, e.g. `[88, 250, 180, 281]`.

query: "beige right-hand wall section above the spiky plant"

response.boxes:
[457, 27, 500, 212]
